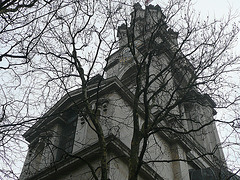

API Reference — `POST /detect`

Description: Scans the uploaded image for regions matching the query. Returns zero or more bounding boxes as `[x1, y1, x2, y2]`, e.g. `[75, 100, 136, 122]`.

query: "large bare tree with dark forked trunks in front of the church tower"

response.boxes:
[0, 0, 239, 180]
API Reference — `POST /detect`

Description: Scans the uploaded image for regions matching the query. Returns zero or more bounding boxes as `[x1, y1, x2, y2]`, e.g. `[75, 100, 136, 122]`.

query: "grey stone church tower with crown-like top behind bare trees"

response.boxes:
[20, 4, 236, 180]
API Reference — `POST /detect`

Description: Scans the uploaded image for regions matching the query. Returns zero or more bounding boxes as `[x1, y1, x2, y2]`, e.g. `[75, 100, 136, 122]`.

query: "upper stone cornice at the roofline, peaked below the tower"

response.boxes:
[23, 76, 143, 141]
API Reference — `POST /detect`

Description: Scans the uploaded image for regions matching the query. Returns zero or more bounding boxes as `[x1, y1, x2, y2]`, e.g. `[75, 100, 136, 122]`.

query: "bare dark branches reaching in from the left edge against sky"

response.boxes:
[0, 0, 70, 179]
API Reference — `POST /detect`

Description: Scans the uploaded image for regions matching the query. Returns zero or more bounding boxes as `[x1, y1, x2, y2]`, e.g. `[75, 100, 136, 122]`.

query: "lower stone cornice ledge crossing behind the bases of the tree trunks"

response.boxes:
[26, 135, 163, 180]
